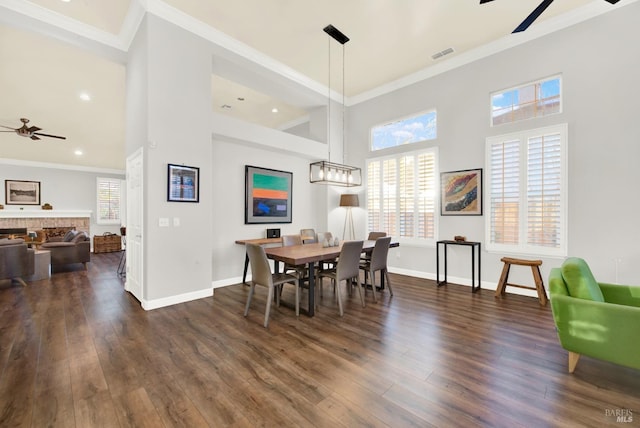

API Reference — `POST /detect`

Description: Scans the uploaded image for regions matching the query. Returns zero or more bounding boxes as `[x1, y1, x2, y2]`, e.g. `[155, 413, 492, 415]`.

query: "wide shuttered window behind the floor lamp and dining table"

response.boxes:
[367, 149, 437, 241]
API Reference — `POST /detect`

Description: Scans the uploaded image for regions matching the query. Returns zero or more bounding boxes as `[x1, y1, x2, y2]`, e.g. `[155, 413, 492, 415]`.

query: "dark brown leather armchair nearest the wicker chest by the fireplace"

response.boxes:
[40, 229, 91, 270]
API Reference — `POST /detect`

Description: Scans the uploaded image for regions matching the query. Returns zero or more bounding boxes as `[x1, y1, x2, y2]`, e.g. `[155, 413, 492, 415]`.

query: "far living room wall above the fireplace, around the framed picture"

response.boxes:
[0, 162, 124, 236]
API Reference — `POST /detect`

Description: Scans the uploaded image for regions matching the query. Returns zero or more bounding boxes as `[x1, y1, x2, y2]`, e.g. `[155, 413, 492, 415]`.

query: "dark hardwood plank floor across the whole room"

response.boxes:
[0, 253, 640, 428]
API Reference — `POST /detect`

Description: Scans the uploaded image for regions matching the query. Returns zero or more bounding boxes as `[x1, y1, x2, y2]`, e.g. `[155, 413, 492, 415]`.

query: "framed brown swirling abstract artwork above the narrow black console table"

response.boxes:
[440, 168, 482, 215]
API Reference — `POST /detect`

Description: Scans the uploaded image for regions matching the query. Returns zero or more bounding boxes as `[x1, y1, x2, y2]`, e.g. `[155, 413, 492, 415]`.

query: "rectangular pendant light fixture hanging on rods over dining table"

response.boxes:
[309, 25, 362, 187]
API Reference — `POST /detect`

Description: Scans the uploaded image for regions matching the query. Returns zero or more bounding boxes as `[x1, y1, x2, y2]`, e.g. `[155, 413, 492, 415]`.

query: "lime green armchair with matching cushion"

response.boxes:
[549, 257, 640, 373]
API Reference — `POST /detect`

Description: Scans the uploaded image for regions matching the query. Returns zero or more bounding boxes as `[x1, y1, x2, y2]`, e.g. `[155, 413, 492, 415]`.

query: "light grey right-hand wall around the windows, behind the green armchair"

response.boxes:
[348, 3, 640, 287]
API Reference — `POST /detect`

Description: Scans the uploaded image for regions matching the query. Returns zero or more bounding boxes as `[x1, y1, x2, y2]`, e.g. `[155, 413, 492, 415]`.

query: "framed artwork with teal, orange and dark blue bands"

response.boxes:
[244, 165, 293, 224]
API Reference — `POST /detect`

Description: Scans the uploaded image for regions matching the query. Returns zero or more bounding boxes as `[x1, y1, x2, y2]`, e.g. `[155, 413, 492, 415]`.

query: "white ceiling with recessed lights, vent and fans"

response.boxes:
[0, 0, 637, 170]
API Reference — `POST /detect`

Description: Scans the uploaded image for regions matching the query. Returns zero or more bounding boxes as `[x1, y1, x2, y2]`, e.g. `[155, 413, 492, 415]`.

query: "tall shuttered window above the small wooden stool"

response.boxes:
[486, 124, 567, 256]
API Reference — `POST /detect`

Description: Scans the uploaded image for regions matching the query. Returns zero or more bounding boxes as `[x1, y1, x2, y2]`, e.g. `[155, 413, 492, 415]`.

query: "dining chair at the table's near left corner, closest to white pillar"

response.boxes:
[244, 244, 300, 328]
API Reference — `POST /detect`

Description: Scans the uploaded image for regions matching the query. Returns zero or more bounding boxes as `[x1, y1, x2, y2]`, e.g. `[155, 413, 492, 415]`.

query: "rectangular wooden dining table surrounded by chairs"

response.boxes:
[264, 240, 399, 317]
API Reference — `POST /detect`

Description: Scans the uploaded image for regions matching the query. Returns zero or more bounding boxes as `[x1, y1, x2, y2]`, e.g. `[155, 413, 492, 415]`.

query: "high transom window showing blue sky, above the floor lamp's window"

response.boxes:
[371, 110, 437, 151]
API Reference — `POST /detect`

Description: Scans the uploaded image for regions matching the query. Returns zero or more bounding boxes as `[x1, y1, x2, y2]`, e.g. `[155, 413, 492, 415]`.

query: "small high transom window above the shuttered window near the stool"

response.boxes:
[491, 76, 561, 126]
